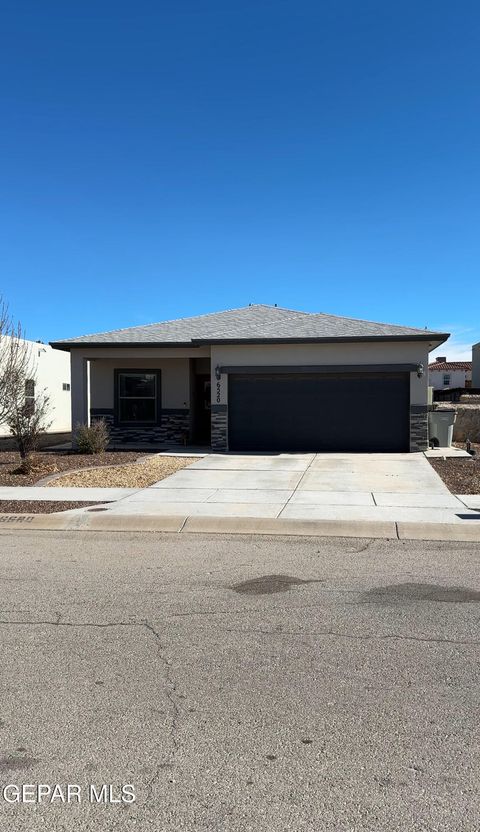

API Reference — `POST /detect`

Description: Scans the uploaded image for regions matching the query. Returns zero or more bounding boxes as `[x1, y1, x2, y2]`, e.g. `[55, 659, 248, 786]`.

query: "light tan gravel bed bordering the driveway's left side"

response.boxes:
[48, 455, 197, 488]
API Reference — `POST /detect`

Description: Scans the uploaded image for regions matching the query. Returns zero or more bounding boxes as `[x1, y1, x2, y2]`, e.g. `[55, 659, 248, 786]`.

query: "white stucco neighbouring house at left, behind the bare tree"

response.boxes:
[0, 335, 71, 438]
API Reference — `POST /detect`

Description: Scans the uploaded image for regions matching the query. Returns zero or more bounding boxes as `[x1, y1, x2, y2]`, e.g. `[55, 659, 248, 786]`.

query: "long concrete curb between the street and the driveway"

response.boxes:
[0, 512, 480, 543]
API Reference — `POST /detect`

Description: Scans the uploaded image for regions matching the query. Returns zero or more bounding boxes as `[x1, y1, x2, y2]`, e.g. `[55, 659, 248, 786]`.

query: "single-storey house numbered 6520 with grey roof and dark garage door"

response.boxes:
[52, 304, 448, 452]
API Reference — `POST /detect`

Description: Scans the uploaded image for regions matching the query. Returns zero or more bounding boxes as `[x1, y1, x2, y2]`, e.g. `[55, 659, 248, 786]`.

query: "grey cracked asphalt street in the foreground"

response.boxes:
[0, 530, 480, 832]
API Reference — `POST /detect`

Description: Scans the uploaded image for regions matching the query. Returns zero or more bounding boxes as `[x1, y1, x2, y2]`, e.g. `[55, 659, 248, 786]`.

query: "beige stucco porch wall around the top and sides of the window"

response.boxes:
[90, 353, 190, 408]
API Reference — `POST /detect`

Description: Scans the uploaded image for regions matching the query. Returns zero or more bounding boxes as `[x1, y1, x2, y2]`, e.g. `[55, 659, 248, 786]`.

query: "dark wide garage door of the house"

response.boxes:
[228, 373, 410, 451]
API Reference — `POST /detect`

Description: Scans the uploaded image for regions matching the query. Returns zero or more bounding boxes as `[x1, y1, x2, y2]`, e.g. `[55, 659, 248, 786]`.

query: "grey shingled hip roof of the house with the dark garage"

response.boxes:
[52, 304, 448, 349]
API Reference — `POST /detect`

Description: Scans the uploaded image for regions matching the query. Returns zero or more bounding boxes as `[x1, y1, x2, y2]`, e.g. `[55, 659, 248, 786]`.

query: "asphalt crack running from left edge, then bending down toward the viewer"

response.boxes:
[0, 613, 182, 801]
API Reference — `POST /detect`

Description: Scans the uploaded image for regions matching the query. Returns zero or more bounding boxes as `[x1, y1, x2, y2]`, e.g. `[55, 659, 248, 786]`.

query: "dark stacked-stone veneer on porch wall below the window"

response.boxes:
[90, 408, 190, 445]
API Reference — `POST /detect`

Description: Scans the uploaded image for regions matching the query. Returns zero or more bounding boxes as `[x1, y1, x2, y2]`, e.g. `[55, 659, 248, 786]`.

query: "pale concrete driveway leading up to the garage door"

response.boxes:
[105, 453, 467, 523]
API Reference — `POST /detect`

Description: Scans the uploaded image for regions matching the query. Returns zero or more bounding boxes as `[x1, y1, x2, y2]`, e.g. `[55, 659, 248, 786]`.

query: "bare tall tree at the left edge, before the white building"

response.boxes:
[0, 298, 51, 471]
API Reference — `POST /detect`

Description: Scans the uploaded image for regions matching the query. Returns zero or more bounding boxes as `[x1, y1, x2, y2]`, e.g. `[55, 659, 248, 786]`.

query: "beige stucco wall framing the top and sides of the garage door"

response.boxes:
[211, 341, 433, 405]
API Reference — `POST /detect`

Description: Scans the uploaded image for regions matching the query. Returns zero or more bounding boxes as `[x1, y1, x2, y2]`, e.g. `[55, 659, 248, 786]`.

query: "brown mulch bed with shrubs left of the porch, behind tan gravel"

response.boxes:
[0, 451, 149, 486]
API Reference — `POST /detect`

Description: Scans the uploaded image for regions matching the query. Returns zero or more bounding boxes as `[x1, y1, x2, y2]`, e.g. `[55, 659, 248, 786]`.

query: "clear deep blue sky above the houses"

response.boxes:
[0, 0, 480, 358]
